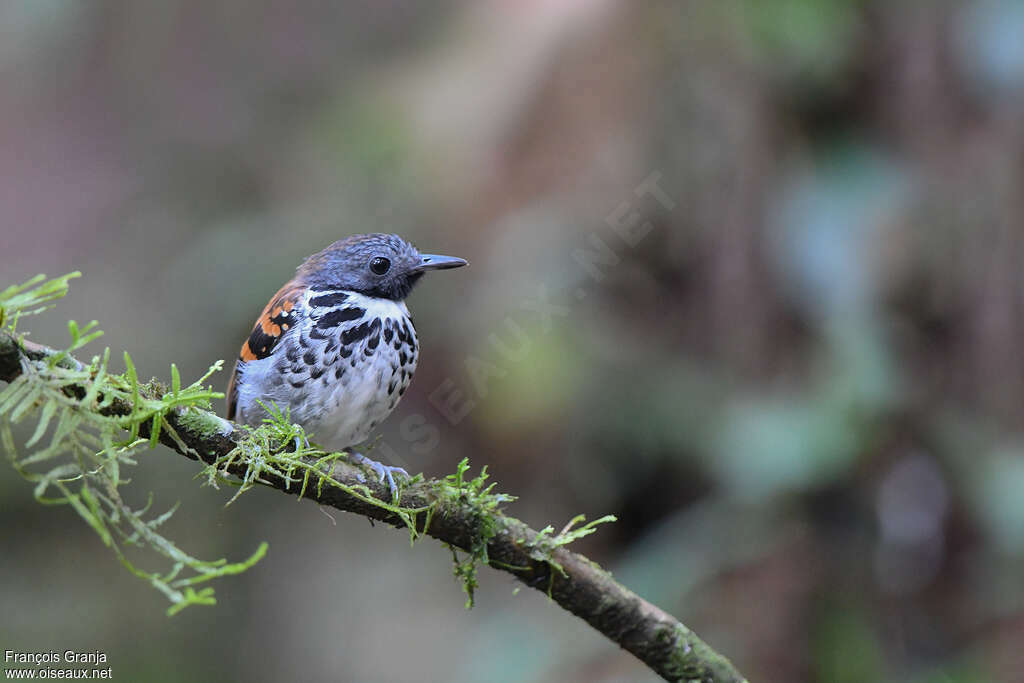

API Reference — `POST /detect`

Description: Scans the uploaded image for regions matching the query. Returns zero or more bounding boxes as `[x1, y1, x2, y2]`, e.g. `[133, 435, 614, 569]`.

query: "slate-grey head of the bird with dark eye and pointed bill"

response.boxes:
[298, 232, 466, 301]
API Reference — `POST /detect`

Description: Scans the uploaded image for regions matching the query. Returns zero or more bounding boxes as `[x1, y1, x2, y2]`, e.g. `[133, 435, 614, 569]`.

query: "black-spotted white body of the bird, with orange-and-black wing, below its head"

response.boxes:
[236, 289, 419, 449]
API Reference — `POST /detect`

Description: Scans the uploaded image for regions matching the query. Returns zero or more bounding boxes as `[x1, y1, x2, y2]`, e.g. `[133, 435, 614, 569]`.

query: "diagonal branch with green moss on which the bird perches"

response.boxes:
[0, 281, 744, 682]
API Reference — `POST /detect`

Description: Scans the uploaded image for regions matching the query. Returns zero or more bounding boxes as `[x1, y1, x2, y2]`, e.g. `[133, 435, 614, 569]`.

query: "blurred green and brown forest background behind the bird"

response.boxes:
[0, 0, 1024, 683]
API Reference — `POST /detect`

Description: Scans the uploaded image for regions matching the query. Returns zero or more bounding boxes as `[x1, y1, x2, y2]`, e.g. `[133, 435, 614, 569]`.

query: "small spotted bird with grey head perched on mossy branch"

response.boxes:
[225, 232, 468, 497]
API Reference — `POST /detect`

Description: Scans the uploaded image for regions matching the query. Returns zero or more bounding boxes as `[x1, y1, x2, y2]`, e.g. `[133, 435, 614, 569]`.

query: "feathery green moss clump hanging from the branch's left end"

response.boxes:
[0, 273, 266, 614]
